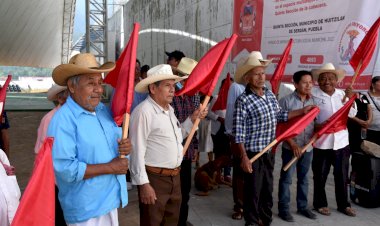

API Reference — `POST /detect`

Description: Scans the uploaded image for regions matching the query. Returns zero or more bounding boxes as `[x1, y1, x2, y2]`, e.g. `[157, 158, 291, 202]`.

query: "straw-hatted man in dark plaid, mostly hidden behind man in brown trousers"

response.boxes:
[169, 57, 200, 226]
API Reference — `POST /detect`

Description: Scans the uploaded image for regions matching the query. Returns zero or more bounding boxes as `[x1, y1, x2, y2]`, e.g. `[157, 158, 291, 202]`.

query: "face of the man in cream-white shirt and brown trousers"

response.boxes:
[149, 79, 175, 108]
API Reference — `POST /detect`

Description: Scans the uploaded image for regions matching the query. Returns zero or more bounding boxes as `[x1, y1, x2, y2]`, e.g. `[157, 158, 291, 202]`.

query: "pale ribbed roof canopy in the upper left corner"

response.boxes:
[0, 0, 75, 68]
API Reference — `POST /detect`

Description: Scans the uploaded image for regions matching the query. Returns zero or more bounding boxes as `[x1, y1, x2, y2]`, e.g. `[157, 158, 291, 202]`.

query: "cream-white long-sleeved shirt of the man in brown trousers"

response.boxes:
[129, 96, 193, 185]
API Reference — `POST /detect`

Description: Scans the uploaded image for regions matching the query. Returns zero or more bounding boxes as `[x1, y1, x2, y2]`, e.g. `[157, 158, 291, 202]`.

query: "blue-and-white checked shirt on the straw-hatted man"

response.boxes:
[232, 86, 288, 152]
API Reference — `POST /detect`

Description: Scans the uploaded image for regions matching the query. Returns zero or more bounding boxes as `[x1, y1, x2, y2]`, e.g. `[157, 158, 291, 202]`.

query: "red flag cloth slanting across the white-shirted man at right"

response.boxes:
[316, 95, 356, 137]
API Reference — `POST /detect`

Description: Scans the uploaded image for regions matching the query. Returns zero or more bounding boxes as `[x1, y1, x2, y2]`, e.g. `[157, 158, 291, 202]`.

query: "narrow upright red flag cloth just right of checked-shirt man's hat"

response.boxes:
[270, 38, 293, 95]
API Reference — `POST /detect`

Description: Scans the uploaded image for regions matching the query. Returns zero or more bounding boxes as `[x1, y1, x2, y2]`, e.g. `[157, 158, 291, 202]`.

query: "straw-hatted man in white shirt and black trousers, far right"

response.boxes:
[311, 63, 357, 216]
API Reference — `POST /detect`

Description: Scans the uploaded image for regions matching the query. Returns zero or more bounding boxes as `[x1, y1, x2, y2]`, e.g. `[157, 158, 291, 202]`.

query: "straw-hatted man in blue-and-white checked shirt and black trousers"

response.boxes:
[232, 51, 311, 225]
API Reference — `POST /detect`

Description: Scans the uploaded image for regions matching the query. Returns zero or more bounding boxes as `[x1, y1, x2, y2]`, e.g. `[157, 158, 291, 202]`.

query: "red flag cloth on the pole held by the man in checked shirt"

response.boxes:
[276, 106, 319, 142]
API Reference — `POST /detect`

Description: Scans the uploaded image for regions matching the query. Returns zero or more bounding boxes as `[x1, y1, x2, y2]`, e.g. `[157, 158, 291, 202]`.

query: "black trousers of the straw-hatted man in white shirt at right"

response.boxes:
[312, 145, 351, 210]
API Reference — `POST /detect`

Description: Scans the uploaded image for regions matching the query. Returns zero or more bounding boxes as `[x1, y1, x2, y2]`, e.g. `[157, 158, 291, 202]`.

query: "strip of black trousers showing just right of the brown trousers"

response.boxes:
[178, 159, 192, 226]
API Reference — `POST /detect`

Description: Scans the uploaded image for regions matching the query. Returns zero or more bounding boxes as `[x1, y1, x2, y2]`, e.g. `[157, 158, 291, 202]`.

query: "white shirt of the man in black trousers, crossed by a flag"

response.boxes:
[312, 87, 357, 150]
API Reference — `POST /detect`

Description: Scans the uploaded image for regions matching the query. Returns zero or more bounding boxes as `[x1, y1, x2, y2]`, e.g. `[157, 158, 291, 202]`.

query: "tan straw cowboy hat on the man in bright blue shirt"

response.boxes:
[53, 53, 115, 86]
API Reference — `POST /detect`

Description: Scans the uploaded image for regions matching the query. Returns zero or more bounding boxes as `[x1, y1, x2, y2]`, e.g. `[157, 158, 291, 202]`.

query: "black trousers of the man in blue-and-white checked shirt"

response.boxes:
[243, 152, 274, 225]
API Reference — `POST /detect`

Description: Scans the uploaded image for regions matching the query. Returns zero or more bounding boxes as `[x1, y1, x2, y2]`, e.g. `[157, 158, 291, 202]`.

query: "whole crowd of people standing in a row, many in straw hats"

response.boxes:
[0, 50, 380, 226]
